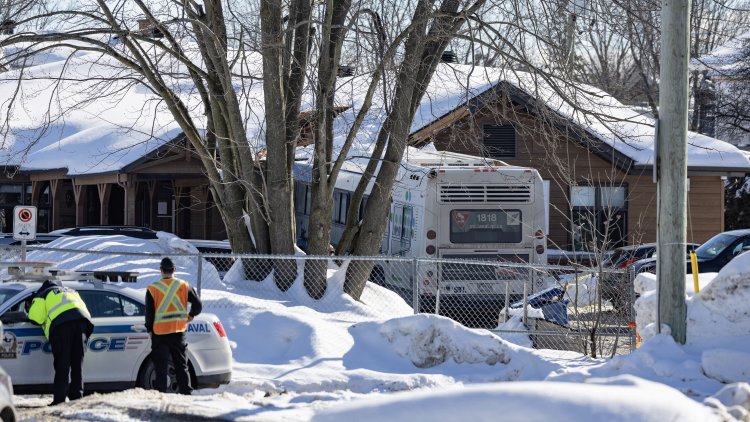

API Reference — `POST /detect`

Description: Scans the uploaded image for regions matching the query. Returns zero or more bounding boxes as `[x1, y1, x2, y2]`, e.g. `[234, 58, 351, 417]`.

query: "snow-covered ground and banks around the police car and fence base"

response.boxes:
[5, 235, 750, 421]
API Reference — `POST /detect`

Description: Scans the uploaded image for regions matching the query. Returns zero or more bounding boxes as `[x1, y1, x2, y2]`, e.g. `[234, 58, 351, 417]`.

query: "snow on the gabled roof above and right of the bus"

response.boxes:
[412, 64, 750, 170]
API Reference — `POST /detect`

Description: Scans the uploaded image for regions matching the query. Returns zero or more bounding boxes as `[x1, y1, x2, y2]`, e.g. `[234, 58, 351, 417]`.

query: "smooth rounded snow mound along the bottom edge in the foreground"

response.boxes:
[313, 376, 721, 422]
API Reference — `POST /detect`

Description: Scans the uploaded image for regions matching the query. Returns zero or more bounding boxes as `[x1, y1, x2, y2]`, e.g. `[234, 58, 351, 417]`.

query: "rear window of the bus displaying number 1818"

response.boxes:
[450, 210, 522, 243]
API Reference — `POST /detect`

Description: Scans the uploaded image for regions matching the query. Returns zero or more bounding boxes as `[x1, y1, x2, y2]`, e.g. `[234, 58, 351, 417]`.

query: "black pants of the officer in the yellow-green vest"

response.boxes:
[49, 319, 88, 404]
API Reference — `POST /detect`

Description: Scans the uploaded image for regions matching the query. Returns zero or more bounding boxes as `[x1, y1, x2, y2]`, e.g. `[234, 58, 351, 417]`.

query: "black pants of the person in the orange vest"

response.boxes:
[151, 333, 193, 394]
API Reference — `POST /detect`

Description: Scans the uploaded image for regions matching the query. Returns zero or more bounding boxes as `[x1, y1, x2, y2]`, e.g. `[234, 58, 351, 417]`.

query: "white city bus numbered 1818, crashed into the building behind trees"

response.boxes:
[295, 149, 547, 324]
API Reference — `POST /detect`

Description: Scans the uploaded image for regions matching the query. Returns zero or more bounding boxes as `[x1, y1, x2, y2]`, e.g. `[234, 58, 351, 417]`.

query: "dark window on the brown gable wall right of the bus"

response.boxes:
[570, 185, 628, 252]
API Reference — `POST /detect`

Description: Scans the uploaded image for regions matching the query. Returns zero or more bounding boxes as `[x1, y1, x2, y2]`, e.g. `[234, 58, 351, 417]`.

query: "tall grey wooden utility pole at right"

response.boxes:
[654, 0, 690, 344]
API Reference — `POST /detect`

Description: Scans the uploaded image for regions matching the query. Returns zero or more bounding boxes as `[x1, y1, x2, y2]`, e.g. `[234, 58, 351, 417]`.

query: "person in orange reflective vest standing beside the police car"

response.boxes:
[146, 258, 203, 394]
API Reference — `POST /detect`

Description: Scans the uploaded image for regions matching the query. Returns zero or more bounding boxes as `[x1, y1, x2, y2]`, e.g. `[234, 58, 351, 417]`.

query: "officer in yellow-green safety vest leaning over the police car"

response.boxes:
[29, 280, 94, 406]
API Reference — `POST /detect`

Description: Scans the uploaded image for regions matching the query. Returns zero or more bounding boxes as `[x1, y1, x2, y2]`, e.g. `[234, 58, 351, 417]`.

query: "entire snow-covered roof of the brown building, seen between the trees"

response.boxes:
[0, 40, 750, 176]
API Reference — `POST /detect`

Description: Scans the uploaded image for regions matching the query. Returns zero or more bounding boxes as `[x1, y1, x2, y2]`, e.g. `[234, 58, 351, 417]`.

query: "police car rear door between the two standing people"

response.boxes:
[78, 289, 151, 383]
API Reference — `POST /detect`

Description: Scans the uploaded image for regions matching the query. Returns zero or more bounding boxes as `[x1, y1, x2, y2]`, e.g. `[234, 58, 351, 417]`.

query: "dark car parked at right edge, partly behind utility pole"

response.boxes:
[634, 229, 750, 274]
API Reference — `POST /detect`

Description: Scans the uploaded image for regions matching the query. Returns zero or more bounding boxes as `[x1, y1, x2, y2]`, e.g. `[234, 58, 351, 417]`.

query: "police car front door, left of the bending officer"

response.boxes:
[0, 293, 55, 385]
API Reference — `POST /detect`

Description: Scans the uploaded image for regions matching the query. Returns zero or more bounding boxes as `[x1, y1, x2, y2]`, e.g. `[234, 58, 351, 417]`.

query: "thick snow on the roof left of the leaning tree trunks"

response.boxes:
[0, 41, 194, 176]
